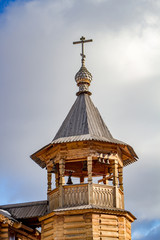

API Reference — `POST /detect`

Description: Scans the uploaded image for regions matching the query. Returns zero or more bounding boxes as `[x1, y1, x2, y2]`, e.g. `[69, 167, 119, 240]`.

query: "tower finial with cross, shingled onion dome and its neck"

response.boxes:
[73, 36, 93, 96]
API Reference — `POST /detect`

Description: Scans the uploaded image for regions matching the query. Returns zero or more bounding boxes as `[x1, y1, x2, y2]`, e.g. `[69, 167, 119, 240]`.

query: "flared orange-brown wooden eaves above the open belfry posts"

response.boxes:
[30, 140, 138, 168]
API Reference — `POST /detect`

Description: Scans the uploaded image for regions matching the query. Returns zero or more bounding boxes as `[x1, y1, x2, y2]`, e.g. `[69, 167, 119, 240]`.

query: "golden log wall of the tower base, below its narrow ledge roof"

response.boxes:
[41, 213, 131, 240]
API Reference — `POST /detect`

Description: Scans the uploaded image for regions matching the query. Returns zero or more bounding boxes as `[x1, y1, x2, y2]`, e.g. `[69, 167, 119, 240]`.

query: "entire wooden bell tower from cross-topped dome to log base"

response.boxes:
[31, 37, 137, 240]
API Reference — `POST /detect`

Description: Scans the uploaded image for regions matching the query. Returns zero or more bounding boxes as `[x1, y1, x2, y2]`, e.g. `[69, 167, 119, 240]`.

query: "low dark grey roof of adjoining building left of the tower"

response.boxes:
[0, 201, 47, 219]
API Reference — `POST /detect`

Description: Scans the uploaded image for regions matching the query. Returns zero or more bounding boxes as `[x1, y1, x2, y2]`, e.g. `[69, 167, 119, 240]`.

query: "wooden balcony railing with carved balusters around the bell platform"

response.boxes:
[48, 184, 124, 211]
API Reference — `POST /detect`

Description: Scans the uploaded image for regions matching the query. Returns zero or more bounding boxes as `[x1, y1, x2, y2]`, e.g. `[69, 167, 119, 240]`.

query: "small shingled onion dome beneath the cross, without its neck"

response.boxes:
[75, 65, 92, 85]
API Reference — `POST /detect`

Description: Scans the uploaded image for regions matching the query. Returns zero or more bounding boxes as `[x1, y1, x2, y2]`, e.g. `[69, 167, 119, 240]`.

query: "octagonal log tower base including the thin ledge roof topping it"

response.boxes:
[40, 206, 136, 240]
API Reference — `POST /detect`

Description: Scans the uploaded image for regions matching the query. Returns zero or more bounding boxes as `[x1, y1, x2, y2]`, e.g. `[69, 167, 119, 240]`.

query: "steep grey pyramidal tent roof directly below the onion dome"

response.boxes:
[52, 93, 127, 145]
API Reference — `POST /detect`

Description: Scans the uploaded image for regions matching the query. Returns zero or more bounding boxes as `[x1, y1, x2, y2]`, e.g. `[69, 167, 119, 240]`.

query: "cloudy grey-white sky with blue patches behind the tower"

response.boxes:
[0, 0, 160, 240]
